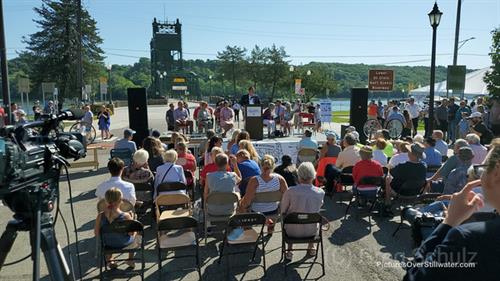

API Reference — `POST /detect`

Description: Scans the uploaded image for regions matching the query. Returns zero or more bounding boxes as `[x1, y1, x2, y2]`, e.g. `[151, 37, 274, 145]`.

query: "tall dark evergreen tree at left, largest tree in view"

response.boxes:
[24, 0, 103, 102]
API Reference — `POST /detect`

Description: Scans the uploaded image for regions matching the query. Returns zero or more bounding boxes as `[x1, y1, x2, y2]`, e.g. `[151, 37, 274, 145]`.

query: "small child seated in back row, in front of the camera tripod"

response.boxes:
[94, 187, 135, 269]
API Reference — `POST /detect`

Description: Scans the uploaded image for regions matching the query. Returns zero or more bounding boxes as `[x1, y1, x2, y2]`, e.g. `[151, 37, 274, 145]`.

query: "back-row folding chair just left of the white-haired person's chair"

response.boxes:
[218, 213, 266, 275]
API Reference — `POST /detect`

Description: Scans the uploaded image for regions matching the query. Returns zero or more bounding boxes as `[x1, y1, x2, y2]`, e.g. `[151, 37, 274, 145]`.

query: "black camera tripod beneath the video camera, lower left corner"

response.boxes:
[0, 186, 73, 281]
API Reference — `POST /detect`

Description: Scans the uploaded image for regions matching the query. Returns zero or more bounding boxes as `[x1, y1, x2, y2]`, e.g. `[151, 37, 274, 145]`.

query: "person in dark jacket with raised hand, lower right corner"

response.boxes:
[403, 139, 500, 281]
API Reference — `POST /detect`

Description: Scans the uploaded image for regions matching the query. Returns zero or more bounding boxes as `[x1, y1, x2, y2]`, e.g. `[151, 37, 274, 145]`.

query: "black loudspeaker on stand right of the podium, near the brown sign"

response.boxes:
[349, 88, 368, 143]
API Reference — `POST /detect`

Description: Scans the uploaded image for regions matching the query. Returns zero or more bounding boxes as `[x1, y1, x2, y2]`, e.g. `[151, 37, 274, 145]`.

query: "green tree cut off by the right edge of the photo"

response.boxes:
[484, 27, 500, 99]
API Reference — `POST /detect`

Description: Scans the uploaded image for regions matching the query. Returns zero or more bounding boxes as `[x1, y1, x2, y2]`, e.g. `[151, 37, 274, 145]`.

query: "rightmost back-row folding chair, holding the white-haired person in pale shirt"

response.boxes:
[280, 213, 325, 276]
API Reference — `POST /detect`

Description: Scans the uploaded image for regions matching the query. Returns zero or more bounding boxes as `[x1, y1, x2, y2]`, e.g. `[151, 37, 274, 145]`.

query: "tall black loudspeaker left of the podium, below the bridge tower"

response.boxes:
[127, 88, 149, 147]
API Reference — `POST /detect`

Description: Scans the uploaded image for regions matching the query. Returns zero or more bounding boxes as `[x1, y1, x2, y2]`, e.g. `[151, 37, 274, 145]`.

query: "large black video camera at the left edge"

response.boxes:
[0, 108, 86, 215]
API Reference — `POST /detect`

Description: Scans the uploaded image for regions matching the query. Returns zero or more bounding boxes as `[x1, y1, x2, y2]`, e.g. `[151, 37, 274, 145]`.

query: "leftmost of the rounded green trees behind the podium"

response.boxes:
[217, 46, 247, 95]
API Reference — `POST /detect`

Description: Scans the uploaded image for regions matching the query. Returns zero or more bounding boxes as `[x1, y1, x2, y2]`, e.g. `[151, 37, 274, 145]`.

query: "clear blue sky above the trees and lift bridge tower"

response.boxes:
[3, 0, 500, 68]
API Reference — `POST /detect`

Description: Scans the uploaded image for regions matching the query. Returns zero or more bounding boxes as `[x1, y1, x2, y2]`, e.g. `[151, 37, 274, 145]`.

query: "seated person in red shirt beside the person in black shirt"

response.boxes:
[352, 145, 384, 191]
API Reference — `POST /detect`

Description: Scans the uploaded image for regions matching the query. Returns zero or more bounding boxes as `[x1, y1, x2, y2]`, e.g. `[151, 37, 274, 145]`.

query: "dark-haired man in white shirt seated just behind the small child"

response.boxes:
[95, 157, 136, 205]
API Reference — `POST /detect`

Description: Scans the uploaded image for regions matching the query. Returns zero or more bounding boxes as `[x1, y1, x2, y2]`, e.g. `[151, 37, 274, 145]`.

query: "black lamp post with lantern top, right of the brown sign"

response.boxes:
[429, 2, 443, 132]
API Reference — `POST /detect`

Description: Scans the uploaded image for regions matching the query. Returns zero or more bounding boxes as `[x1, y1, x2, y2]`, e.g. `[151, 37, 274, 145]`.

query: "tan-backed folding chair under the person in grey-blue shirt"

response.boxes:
[203, 192, 239, 245]
